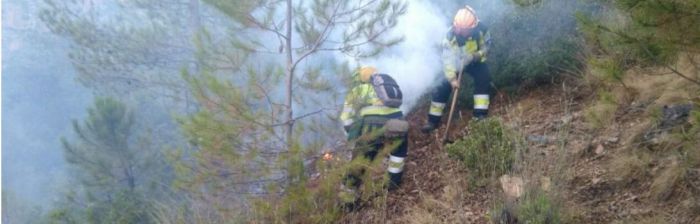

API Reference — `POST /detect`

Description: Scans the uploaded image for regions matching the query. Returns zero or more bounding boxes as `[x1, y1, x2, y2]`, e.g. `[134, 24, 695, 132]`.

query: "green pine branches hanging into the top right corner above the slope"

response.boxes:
[579, 0, 700, 85]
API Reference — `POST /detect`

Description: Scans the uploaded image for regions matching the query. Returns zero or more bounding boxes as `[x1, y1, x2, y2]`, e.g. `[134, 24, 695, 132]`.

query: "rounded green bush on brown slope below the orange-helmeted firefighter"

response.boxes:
[447, 118, 520, 185]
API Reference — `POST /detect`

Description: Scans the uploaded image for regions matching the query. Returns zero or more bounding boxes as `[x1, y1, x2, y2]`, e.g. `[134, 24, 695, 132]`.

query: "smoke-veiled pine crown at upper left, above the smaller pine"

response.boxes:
[39, 0, 207, 100]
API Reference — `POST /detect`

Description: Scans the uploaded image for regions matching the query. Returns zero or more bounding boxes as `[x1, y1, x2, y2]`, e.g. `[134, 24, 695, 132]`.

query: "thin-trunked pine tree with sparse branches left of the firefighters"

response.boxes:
[170, 0, 405, 221]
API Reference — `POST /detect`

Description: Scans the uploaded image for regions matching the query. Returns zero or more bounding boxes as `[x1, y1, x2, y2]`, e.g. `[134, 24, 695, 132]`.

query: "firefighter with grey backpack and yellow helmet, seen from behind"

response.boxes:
[340, 67, 408, 198]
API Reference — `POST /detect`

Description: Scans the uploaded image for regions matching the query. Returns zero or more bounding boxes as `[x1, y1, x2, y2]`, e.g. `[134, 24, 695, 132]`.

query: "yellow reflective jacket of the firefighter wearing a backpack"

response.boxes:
[340, 83, 401, 126]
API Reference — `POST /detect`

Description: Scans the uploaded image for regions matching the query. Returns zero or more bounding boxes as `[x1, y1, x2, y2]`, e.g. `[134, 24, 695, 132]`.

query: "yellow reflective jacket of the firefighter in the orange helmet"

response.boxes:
[442, 23, 491, 80]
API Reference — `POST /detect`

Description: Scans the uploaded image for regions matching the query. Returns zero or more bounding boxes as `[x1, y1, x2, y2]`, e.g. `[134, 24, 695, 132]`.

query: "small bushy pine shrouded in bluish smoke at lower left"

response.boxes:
[54, 98, 163, 223]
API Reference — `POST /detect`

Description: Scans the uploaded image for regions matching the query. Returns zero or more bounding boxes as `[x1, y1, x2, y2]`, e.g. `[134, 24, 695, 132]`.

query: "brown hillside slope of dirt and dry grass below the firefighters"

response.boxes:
[342, 70, 700, 223]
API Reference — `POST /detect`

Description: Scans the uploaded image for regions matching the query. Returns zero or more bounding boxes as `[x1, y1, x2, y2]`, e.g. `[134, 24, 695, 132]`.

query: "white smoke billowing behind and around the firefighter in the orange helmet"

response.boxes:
[350, 0, 585, 112]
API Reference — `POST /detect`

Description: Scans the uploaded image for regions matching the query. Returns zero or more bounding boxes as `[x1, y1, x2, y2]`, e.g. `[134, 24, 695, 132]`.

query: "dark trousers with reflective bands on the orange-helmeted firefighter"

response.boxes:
[428, 63, 491, 124]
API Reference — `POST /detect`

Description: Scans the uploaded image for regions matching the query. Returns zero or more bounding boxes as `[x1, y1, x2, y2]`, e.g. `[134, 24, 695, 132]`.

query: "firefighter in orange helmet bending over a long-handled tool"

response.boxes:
[421, 6, 491, 132]
